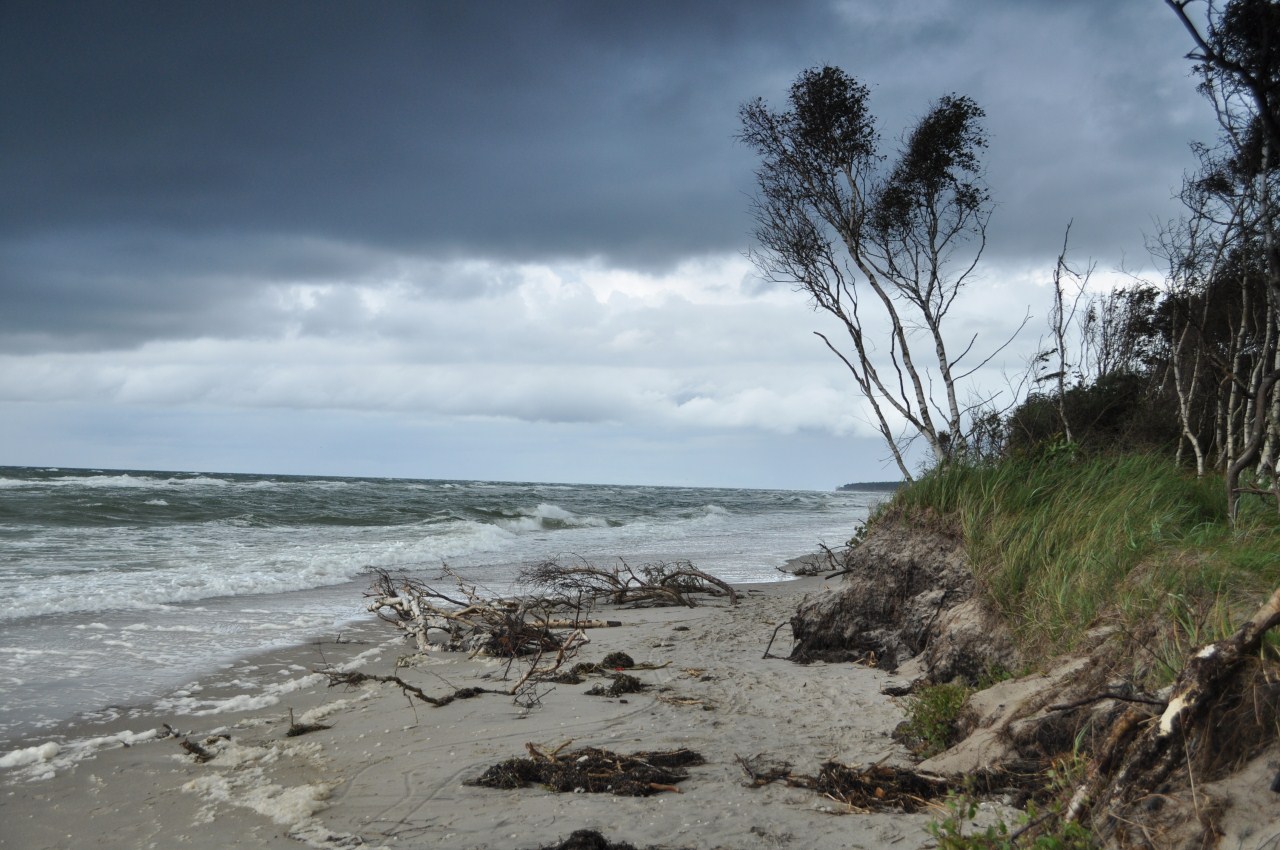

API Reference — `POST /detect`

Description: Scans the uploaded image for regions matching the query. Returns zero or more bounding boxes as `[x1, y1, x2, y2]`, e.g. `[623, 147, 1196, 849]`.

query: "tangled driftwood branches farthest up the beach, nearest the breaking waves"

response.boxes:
[520, 558, 737, 608]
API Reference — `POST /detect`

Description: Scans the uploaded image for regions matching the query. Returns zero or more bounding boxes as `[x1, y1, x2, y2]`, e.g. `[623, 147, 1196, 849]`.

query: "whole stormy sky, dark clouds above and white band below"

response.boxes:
[0, 0, 1213, 489]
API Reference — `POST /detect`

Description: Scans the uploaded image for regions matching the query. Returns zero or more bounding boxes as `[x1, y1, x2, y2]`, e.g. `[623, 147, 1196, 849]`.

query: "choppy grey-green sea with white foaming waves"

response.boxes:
[0, 467, 884, 750]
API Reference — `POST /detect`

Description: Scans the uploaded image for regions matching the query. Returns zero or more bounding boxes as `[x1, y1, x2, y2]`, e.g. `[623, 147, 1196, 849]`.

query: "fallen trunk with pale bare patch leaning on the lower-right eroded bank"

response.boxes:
[1066, 589, 1280, 837]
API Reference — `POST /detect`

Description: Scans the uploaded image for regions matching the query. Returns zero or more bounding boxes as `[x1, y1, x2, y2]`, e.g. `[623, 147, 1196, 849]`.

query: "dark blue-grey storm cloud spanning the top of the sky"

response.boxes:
[0, 0, 1206, 348]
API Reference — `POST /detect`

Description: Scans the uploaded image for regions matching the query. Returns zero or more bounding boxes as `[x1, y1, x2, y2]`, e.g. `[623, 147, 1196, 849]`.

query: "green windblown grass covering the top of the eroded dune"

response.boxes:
[884, 454, 1280, 668]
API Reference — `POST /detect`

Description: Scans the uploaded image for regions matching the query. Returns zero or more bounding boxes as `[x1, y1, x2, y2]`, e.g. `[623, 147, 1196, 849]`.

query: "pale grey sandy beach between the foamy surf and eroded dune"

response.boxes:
[0, 579, 937, 850]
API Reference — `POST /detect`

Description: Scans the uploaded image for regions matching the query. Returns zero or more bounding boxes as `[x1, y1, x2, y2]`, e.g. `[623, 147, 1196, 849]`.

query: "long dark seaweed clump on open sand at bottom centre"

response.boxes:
[463, 746, 705, 796]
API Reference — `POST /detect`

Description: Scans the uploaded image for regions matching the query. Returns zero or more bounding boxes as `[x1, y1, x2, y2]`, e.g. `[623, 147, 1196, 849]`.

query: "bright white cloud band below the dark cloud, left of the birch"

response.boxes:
[0, 257, 880, 434]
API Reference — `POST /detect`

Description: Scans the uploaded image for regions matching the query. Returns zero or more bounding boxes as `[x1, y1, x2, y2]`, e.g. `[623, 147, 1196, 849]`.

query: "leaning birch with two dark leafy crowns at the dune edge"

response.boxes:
[740, 67, 998, 480]
